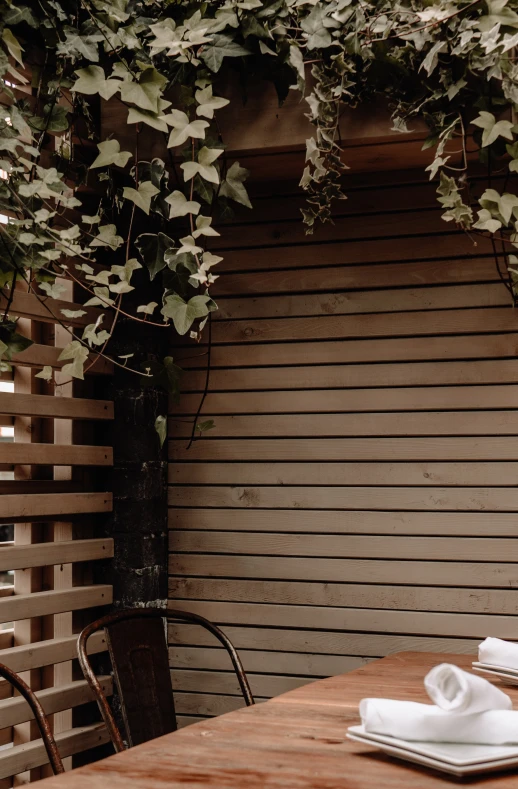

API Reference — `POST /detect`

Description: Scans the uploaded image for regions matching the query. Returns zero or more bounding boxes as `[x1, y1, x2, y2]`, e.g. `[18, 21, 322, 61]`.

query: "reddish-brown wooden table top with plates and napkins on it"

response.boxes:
[40, 652, 518, 789]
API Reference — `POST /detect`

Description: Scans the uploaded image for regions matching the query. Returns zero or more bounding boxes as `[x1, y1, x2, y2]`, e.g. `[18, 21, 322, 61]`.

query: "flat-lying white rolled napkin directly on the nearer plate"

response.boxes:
[360, 699, 518, 745]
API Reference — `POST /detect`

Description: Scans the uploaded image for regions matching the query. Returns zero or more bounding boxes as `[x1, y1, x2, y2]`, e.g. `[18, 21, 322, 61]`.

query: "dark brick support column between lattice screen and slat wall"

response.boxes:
[106, 292, 169, 608]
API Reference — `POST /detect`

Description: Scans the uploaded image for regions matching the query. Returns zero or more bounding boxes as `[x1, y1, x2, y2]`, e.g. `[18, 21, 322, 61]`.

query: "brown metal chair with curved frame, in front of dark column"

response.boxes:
[77, 608, 254, 752]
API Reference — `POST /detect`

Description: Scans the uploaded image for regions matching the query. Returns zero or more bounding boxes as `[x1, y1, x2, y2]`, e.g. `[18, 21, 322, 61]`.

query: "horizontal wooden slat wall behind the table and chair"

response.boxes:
[170, 173, 518, 724]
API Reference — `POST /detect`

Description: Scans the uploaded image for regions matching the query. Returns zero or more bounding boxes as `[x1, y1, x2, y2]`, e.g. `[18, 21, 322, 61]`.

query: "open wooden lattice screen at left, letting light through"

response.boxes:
[0, 278, 113, 789]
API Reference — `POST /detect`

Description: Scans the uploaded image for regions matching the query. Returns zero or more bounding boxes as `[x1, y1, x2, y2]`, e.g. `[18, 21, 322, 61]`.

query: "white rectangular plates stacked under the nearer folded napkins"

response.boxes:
[347, 726, 518, 775]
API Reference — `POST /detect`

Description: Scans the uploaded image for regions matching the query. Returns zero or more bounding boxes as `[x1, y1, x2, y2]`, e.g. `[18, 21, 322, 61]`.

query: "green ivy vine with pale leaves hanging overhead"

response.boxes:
[0, 0, 518, 416]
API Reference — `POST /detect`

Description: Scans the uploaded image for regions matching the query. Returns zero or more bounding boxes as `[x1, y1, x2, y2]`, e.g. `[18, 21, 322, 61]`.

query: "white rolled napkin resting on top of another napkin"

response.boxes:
[424, 663, 513, 714]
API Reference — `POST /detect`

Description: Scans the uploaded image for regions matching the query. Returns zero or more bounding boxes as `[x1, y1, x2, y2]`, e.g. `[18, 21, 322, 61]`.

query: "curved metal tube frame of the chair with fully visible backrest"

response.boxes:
[77, 608, 255, 753]
